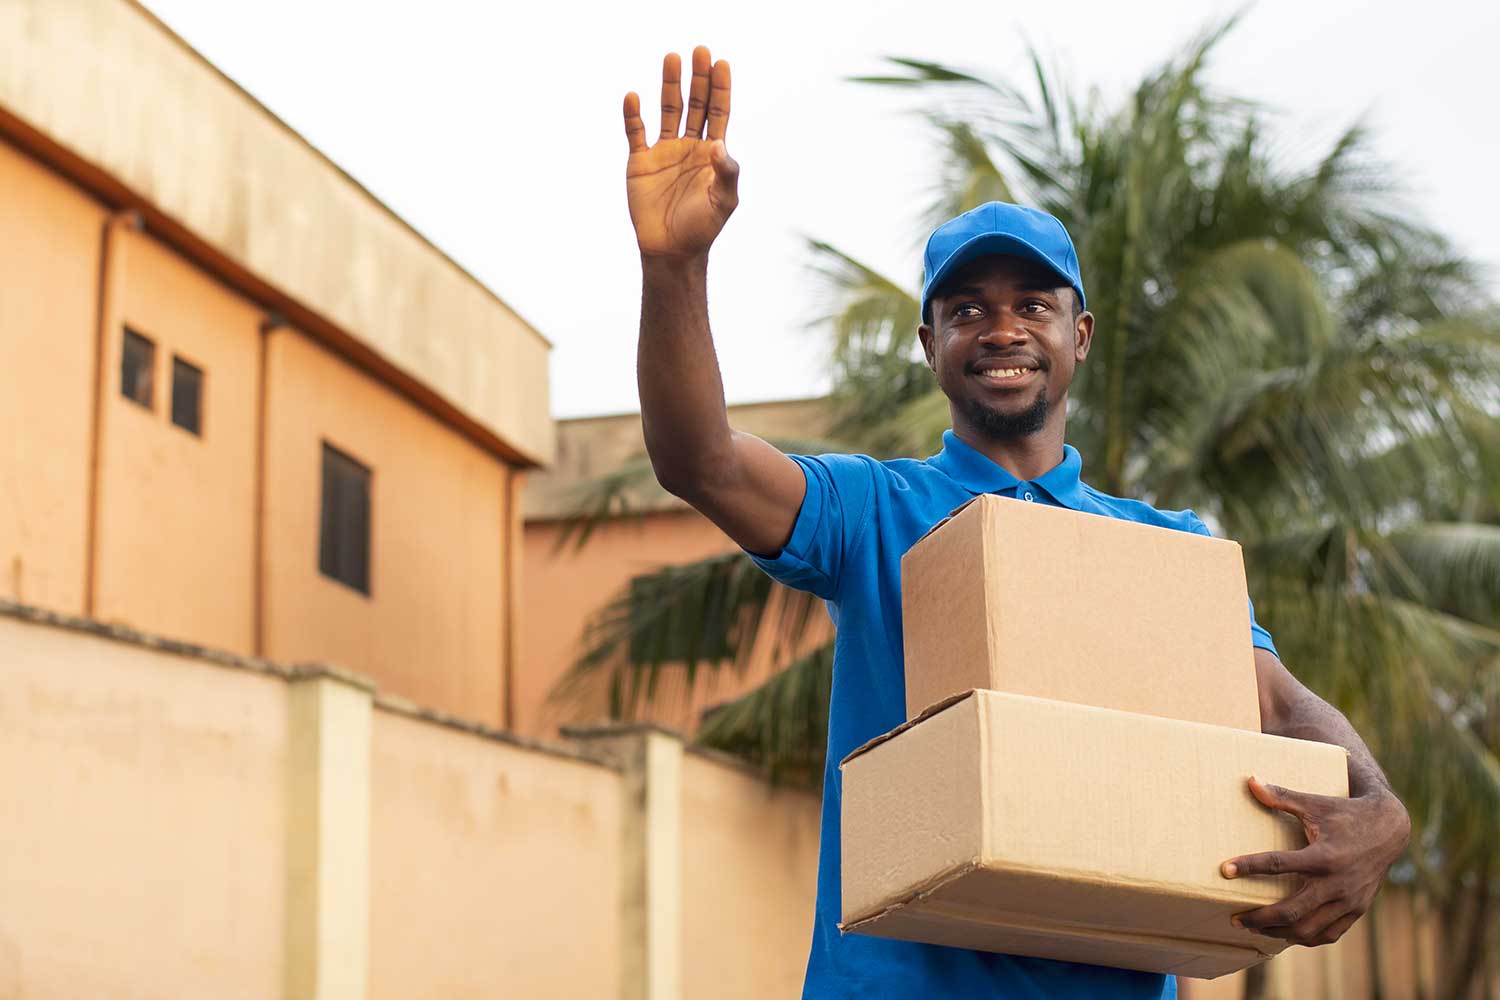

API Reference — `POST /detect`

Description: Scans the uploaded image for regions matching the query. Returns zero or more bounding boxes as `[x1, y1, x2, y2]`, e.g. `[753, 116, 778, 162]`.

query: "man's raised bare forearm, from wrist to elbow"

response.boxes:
[636, 255, 731, 495]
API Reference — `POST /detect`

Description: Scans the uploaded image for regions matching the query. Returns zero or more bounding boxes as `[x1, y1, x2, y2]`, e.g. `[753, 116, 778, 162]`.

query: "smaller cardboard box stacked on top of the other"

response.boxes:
[902, 495, 1260, 733]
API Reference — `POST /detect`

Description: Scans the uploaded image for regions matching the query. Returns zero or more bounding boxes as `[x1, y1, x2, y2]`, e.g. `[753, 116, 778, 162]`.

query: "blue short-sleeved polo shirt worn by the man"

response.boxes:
[752, 430, 1275, 1000]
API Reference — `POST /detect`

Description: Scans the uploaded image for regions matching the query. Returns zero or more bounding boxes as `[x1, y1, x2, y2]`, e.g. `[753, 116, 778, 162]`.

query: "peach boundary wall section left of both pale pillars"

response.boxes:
[0, 615, 287, 1000]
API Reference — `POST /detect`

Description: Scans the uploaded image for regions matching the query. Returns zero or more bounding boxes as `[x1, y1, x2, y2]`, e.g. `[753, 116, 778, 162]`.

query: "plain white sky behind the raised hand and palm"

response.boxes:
[146, 0, 1500, 417]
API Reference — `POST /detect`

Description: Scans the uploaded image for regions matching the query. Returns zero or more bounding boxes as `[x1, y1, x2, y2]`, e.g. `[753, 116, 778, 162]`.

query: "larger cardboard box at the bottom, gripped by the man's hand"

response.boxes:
[840, 691, 1349, 978]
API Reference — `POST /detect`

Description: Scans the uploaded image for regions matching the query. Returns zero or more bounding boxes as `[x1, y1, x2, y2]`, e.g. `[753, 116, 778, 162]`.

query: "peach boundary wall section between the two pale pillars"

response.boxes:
[369, 711, 626, 1000]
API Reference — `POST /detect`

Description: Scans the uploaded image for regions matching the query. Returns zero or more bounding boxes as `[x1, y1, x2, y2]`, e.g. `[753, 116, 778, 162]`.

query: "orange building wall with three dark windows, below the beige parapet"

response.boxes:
[0, 125, 521, 724]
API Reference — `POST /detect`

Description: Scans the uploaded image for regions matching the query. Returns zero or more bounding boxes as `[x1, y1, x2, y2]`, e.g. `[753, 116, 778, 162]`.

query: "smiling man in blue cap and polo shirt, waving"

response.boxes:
[624, 48, 1410, 1000]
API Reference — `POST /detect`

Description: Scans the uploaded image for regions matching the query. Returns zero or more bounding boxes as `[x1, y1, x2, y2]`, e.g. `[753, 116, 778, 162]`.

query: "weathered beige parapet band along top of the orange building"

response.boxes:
[0, 0, 554, 462]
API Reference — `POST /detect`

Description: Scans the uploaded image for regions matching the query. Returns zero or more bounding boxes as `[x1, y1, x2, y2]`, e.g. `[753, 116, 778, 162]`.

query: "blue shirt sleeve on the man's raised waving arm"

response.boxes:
[746, 454, 875, 601]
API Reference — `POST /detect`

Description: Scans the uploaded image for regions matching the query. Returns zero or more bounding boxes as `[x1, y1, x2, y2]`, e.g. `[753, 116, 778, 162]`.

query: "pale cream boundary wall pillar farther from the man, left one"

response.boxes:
[287, 667, 374, 1000]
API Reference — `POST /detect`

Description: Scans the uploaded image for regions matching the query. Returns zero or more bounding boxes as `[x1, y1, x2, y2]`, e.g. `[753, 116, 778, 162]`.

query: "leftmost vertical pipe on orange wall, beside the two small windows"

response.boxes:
[84, 210, 141, 618]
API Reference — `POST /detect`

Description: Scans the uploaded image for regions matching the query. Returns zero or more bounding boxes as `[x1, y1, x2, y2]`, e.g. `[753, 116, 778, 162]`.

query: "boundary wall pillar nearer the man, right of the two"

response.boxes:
[564, 726, 683, 1000]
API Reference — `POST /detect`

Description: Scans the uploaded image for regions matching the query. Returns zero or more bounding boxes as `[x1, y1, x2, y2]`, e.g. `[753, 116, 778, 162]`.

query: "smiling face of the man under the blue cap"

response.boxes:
[918, 256, 1094, 439]
